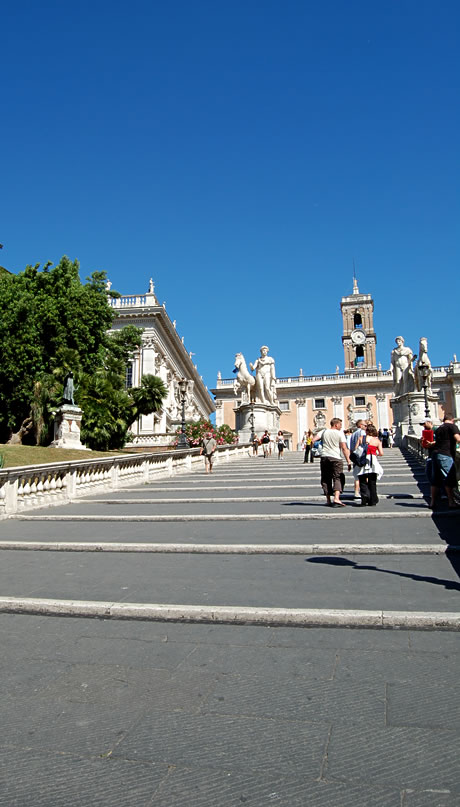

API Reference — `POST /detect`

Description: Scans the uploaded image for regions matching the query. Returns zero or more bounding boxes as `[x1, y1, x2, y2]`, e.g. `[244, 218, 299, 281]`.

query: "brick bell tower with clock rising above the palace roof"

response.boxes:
[340, 276, 377, 372]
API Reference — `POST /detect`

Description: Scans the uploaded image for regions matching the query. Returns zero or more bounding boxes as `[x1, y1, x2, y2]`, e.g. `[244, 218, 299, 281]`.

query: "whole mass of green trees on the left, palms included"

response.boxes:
[0, 257, 167, 449]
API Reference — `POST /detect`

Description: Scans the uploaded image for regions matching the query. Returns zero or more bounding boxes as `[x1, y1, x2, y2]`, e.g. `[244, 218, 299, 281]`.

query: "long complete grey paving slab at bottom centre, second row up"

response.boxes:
[114, 711, 328, 779]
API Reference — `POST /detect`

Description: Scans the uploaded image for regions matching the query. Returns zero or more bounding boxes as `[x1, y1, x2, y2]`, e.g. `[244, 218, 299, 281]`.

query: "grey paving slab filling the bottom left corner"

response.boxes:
[0, 748, 167, 807]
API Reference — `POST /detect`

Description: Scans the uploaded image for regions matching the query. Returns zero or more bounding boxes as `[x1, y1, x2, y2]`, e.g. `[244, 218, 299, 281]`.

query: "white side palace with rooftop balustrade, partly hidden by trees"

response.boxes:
[108, 280, 215, 446]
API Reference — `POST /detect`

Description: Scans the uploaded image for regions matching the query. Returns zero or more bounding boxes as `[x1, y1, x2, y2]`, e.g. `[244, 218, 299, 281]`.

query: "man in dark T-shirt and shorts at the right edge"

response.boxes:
[428, 415, 460, 510]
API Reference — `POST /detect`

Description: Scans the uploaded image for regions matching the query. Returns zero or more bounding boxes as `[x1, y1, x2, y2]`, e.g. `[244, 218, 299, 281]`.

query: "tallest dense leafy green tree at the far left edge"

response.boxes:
[0, 257, 113, 442]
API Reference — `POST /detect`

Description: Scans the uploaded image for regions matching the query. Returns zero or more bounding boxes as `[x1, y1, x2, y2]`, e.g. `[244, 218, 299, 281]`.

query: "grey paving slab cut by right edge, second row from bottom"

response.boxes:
[324, 724, 460, 795]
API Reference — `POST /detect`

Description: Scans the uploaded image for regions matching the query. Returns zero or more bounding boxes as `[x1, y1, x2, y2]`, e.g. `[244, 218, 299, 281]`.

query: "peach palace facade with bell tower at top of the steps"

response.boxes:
[211, 279, 460, 449]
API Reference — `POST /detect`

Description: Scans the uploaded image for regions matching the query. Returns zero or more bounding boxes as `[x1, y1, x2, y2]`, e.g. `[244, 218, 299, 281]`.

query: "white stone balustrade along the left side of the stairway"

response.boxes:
[0, 444, 249, 518]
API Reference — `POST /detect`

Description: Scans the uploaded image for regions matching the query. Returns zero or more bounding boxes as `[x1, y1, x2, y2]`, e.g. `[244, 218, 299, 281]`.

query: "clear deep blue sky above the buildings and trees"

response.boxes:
[0, 0, 460, 386]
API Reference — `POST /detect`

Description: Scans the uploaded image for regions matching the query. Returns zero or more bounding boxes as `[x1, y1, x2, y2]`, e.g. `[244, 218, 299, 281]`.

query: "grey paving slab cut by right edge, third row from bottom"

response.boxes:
[386, 680, 460, 731]
